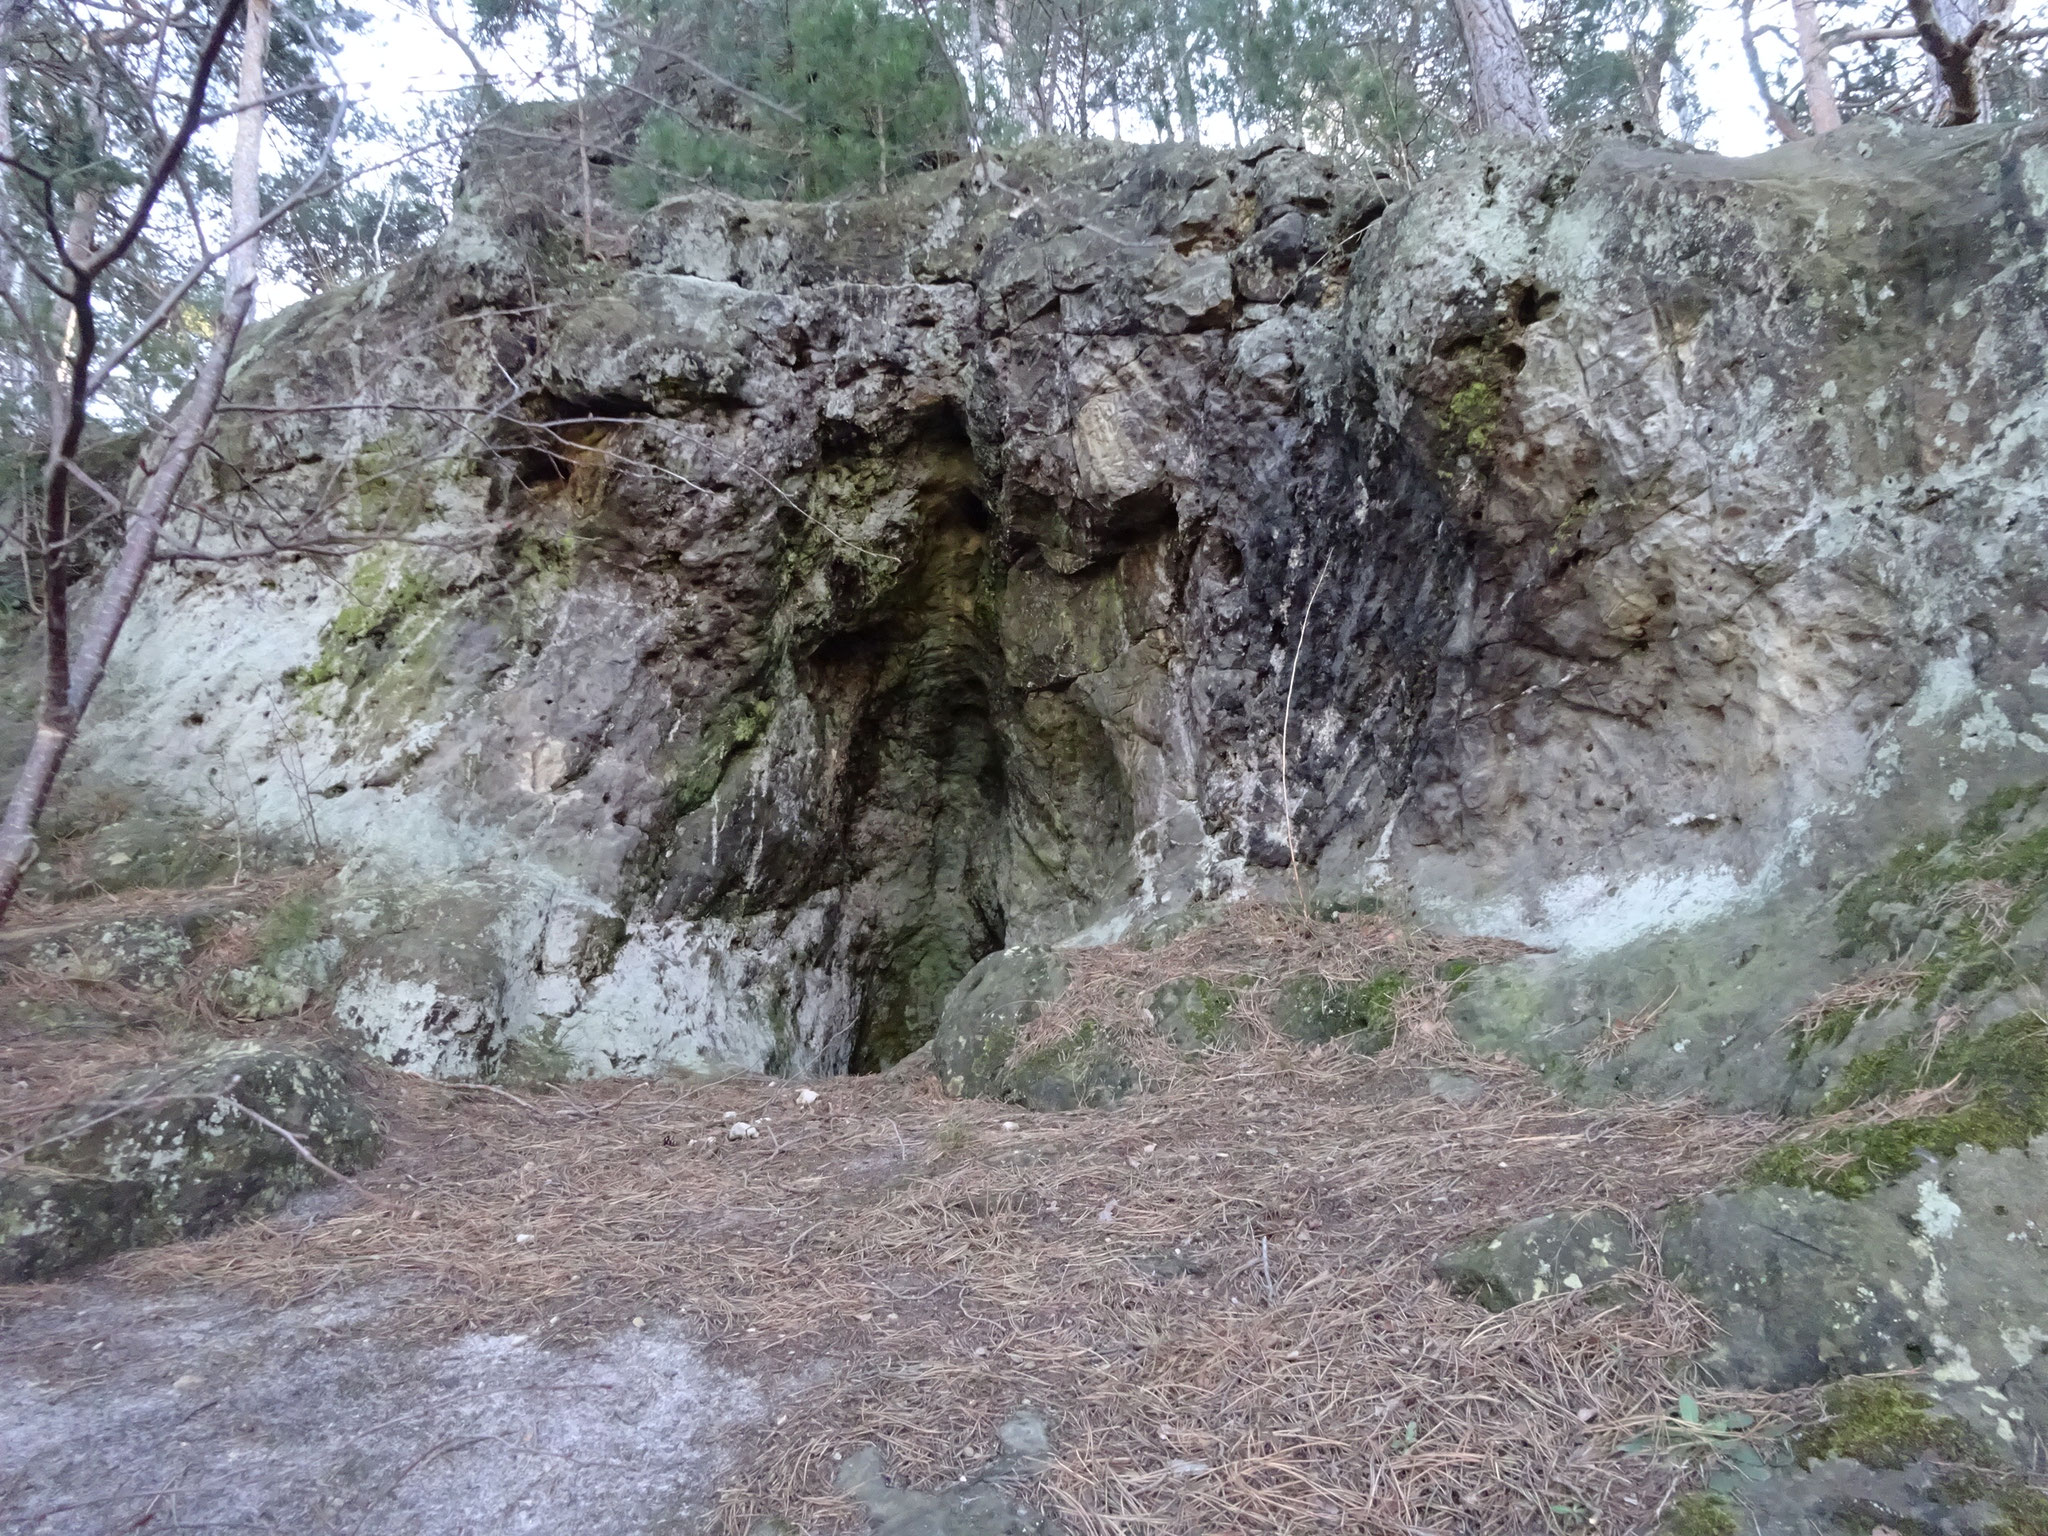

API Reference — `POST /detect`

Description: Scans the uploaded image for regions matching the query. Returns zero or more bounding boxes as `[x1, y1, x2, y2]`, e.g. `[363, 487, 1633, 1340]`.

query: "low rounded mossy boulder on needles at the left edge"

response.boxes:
[0, 1042, 383, 1280]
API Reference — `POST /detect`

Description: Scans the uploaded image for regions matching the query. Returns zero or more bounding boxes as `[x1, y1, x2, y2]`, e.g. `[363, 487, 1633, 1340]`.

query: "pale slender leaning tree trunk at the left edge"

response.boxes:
[0, 0, 270, 918]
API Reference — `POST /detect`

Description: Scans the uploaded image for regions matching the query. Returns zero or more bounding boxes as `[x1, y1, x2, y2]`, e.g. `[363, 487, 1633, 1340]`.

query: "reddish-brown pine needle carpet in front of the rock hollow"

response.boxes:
[4, 909, 1784, 1534]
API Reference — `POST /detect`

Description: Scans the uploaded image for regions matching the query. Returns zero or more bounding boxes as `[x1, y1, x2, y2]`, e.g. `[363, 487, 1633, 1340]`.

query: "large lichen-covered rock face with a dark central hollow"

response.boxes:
[39, 117, 2048, 1073]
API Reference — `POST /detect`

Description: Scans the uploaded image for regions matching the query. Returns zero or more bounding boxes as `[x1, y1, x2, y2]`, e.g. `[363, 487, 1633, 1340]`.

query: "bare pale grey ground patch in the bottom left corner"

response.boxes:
[0, 1286, 766, 1536]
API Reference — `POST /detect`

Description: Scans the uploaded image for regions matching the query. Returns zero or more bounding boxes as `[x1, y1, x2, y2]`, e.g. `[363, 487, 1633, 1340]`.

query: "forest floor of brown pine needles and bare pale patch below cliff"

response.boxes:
[0, 897, 1826, 1536]
